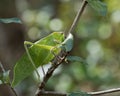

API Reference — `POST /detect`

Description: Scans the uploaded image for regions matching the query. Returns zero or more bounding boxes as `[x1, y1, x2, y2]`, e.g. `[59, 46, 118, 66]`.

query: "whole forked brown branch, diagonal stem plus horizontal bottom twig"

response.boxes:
[36, 0, 120, 96]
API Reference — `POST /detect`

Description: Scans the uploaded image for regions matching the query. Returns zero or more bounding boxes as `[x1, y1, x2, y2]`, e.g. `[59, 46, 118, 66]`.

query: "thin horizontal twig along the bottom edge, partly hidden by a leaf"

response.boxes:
[35, 88, 120, 96]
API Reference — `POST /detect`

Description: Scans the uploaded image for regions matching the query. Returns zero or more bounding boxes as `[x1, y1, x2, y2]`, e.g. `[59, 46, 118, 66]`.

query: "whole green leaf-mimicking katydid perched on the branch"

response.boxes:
[12, 32, 73, 87]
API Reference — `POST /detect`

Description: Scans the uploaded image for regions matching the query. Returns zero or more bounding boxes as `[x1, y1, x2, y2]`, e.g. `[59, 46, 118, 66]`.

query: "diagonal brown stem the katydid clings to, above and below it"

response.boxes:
[36, 0, 87, 96]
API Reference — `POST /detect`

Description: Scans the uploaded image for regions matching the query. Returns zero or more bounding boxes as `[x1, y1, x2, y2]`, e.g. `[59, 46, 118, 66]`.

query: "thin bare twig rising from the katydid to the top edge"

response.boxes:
[68, 0, 87, 34]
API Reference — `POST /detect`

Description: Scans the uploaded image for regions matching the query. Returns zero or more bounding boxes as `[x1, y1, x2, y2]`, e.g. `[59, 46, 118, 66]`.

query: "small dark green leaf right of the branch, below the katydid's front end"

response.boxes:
[66, 56, 87, 64]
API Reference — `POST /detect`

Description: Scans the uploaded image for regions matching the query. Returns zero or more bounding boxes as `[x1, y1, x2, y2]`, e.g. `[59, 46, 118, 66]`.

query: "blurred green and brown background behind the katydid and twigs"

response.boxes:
[0, 0, 120, 96]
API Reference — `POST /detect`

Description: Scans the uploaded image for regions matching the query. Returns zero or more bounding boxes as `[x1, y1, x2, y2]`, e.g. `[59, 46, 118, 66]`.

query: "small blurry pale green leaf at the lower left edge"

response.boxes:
[0, 70, 10, 84]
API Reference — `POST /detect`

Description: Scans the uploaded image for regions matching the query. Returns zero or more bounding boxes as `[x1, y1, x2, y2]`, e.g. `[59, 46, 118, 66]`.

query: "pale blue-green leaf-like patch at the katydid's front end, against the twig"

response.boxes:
[61, 33, 73, 52]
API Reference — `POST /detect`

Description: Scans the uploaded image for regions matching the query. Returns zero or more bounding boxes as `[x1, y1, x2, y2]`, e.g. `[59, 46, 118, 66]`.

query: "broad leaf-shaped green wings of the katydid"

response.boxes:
[12, 32, 64, 87]
